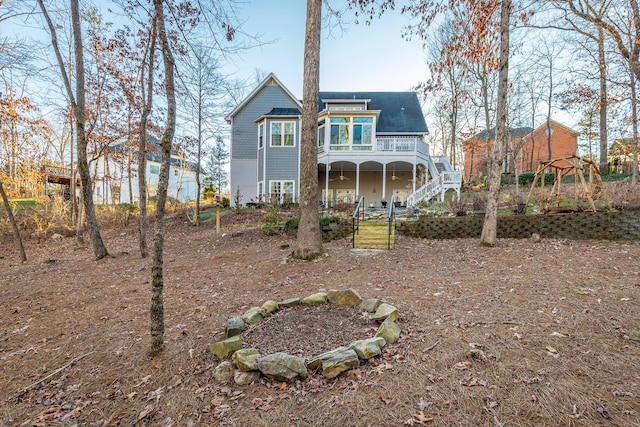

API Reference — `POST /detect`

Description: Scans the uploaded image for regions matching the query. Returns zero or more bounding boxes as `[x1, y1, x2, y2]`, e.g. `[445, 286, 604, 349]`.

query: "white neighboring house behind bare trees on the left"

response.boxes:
[90, 137, 199, 204]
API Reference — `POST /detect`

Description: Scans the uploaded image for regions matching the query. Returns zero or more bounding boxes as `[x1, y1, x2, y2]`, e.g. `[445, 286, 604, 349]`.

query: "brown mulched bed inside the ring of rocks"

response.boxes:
[241, 303, 378, 358]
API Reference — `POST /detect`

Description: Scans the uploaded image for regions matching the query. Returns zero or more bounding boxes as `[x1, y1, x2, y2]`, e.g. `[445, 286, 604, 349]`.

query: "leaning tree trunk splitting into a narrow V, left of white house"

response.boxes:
[37, 0, 109, 259]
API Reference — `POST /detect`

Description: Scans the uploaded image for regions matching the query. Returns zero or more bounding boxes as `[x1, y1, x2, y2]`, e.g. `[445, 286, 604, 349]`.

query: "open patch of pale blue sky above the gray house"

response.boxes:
[222, 0, 428, 98]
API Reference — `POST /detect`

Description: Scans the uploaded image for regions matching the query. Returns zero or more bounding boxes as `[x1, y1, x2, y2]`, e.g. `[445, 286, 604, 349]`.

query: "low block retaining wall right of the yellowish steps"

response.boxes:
[396, 211, 640, 240]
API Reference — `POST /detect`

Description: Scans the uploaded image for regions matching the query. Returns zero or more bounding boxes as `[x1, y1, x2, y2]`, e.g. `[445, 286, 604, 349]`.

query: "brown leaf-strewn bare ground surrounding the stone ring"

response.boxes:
[0, 214, 640, 426]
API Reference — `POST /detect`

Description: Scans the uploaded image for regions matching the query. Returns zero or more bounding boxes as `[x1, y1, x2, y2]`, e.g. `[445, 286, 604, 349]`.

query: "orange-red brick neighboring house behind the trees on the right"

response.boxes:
[463, 120, 579, 180]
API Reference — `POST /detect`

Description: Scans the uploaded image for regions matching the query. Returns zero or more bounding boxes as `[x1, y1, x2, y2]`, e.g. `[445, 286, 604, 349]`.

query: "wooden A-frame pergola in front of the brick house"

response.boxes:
[525, 156, 611, 212]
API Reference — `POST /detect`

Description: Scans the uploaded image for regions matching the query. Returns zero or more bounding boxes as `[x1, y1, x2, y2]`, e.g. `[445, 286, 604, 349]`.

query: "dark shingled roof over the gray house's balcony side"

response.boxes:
[318, 92, 428, 133]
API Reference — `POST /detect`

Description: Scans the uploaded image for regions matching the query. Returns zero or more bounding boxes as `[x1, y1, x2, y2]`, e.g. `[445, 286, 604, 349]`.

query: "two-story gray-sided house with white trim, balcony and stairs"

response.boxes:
[226, 74, 461, 206]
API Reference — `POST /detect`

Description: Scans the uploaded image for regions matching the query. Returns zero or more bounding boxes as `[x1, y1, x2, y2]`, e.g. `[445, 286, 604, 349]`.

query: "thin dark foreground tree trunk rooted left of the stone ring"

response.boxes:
[150, 0, 176, 355]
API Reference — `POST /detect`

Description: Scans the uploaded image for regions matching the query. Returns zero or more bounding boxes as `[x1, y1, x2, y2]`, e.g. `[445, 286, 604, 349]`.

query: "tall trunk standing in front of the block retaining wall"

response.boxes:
[480, 0, 511, 246]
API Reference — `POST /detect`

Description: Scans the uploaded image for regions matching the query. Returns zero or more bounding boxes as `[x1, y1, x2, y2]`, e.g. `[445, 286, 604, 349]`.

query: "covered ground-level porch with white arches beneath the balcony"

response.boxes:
[318, 160, 431, 207]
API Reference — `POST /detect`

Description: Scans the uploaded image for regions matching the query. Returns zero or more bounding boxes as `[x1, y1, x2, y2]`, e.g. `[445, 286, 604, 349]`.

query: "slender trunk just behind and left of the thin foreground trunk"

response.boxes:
[138, 20, 158, 258]
